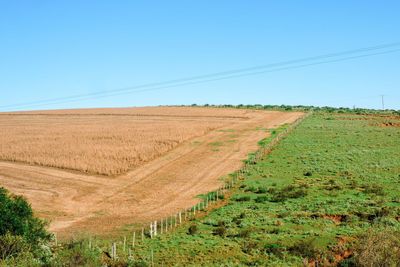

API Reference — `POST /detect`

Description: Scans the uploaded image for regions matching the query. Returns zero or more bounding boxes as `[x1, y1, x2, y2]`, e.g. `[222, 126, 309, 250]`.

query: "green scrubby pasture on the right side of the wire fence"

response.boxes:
[92, 114, 400, 266]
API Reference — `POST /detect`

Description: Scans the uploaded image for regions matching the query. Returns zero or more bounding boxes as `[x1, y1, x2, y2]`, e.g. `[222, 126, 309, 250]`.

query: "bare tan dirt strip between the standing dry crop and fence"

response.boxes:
[0, 108, 301, 238]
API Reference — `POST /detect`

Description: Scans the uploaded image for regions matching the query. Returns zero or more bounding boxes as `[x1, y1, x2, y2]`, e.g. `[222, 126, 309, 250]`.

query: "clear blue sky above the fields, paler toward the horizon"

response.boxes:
[0, 0, 400, 111]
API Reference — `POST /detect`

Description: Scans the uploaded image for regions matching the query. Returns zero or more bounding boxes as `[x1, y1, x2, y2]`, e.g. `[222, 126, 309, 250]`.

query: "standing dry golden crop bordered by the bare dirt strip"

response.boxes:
[0, 107, 253, 175]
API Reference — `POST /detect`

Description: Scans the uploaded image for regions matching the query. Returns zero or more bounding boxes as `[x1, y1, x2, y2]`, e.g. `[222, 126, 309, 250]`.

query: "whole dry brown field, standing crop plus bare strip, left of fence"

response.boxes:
[0, 107, 301, 237]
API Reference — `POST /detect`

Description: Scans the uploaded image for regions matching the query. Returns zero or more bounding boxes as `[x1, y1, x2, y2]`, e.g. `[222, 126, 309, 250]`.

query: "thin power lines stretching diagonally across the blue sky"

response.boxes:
[0, 42, 400, 111]
